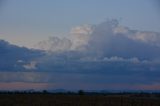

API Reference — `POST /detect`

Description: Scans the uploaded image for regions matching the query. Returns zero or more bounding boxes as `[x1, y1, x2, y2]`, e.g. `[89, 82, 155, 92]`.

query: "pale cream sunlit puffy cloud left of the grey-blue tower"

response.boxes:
[37, 25, 92, 52]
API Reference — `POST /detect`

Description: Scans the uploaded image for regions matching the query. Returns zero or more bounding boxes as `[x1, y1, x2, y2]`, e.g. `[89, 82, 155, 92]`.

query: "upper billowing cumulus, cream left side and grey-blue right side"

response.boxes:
[36, 20, 160, 60]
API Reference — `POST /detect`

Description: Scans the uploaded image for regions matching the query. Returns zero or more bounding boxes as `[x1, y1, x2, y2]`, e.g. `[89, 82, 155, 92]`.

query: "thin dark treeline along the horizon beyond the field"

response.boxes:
[0, 90, 160, 98]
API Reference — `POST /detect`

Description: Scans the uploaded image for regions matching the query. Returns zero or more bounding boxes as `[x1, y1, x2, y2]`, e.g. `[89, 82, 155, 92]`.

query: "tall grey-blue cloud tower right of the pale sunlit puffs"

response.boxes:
[87, 20, 160, 59]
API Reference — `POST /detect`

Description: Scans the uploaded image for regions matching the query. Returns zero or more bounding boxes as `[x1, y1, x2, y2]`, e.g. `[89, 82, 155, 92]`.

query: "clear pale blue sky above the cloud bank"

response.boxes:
[0, 0, 160, 47]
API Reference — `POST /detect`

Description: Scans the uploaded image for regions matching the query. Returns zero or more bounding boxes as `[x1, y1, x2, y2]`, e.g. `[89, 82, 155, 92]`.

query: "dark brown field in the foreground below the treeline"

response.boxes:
[0, 93, 160, 106]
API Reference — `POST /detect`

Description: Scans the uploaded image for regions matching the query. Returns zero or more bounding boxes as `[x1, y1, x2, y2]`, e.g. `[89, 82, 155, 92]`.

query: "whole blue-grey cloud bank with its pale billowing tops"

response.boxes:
[0, 20, 160, 89]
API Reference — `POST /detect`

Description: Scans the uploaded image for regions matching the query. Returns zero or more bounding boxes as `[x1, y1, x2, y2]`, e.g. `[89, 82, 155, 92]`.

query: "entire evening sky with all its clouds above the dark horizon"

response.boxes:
[0, 0, 160, 90]
